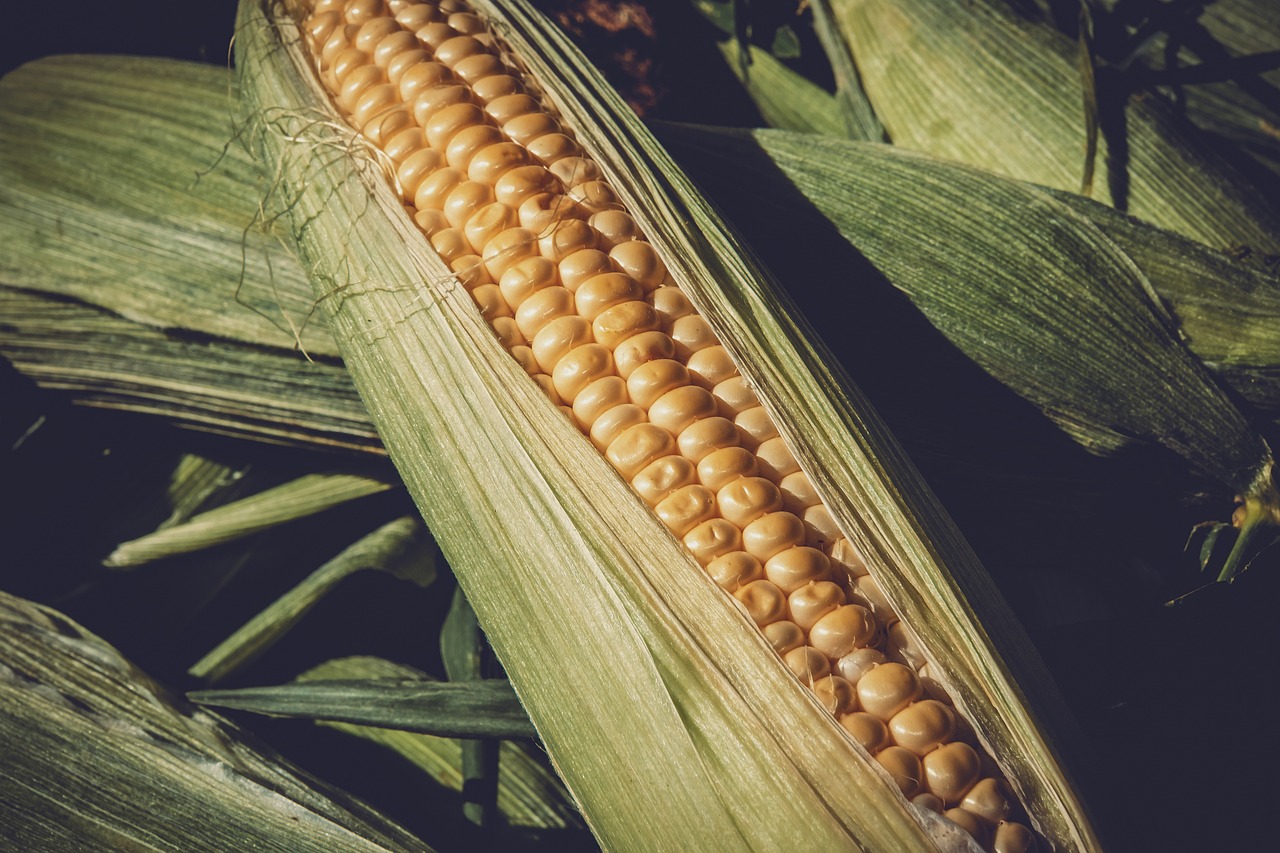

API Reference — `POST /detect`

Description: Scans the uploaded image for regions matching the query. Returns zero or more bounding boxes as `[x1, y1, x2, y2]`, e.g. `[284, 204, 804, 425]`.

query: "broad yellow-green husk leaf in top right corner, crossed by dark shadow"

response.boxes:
[832, 0, 1280, 252]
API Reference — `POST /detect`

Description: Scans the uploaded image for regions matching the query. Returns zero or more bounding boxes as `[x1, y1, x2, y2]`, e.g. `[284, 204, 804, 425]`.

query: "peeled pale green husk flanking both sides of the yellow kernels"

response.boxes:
[237, 0, 1096, 849]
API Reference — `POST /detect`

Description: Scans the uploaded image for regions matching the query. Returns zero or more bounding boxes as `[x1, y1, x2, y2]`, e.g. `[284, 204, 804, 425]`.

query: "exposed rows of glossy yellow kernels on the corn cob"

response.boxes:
[301, 0, 1036, 850]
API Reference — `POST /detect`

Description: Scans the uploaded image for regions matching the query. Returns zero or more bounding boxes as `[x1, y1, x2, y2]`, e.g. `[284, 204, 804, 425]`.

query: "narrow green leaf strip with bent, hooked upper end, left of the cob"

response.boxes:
[188, 517, 436, 683]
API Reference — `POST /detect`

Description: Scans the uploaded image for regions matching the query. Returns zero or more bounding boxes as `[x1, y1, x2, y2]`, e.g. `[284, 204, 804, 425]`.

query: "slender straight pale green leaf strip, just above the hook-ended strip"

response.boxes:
[102, 473, 392, 569]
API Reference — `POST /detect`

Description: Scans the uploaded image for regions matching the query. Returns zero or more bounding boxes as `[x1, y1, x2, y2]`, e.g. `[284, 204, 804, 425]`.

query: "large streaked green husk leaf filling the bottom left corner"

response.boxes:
[0, 593, 429, 852]
